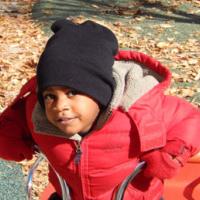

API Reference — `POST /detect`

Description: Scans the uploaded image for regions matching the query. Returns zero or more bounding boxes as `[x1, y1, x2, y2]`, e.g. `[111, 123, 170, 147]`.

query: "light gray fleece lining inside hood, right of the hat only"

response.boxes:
[110, 61, 160, 111]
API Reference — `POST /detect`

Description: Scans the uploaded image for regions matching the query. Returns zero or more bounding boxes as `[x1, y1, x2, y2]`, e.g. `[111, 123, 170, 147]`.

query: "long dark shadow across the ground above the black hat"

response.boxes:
[32, 0, 200, 24]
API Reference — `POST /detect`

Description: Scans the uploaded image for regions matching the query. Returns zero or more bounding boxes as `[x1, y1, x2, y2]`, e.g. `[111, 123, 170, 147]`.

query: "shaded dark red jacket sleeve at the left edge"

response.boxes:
[0, 94, 33, 161]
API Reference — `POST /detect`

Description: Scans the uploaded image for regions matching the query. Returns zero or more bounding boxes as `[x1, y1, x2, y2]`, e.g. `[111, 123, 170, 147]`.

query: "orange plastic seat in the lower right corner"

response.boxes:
[164, 153, 200, 200]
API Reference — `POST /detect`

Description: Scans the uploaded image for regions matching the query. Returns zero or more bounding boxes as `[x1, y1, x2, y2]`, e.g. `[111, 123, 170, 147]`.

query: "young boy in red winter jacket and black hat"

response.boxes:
[0, 19, 200, 200]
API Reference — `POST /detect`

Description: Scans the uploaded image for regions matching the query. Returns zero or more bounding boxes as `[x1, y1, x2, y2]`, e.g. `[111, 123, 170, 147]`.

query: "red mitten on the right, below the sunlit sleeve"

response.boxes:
[141, 140, 191, 179]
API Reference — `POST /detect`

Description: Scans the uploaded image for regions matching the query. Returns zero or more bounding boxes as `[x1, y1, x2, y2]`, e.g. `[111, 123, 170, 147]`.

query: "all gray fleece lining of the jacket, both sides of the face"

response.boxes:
[32, 61, 161, 138]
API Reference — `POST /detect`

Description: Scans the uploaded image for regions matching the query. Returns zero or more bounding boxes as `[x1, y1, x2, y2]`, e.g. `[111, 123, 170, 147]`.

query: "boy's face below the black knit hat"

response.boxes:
[43, 86, 100, 136]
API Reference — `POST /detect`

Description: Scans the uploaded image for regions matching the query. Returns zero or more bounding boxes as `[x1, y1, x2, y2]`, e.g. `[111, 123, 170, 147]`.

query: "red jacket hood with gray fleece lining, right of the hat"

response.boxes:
[97, 51, 171, 128]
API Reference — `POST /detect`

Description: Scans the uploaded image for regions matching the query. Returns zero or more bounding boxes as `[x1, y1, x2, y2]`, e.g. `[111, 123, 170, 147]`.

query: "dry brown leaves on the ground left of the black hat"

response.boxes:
[0, 16, 46, 111]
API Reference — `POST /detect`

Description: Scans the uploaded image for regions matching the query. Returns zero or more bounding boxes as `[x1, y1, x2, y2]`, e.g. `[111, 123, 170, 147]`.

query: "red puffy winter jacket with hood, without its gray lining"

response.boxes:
[0, 51, 200, 200]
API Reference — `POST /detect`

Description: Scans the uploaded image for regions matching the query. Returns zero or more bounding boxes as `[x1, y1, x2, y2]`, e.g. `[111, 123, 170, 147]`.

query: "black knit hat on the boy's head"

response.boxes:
[37, 19, 118, 106]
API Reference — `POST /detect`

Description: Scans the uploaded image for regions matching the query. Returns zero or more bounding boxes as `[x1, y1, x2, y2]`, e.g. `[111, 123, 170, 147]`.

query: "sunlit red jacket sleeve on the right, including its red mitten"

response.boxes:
[141, 96, 200, 179]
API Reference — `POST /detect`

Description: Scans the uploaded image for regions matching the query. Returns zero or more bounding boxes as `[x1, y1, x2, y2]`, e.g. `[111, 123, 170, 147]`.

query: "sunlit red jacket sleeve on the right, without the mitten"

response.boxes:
[162, 96, 200, 155]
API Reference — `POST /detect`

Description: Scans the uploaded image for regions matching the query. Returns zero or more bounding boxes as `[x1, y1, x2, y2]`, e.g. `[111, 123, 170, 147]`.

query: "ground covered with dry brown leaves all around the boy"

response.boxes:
[0, 0, 200, 199]
